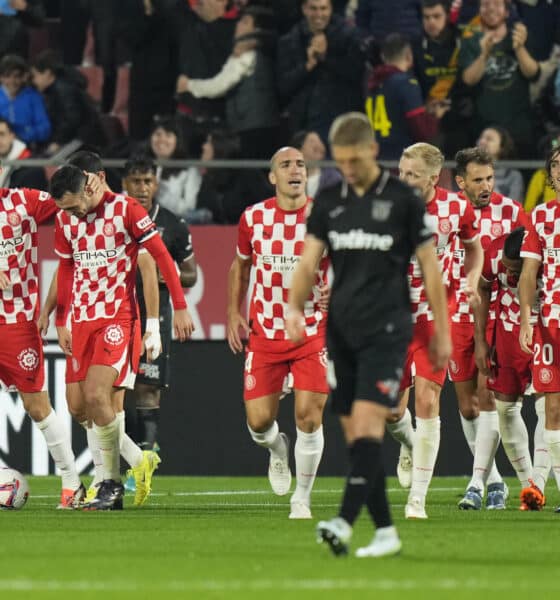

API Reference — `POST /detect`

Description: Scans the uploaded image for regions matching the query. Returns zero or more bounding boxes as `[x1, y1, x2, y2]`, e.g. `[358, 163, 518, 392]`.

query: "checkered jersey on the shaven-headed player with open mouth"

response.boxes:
[237, 198, 328, 341]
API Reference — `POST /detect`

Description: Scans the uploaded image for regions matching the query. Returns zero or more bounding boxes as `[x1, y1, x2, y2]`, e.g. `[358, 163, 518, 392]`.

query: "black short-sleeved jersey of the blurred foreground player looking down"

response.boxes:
[307, 170, 432, 339]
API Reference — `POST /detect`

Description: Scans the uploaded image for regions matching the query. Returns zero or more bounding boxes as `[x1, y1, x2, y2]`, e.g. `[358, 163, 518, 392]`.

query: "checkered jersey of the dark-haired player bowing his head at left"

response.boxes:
[55, 192, 158, 322]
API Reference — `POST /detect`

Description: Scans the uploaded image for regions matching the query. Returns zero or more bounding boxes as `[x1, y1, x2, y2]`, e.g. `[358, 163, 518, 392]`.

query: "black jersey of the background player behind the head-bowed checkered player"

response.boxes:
[136, 200, 194, 315]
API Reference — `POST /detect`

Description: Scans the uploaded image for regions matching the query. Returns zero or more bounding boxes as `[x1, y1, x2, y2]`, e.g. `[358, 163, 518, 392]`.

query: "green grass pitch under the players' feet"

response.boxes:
[0, 477, 560, 600]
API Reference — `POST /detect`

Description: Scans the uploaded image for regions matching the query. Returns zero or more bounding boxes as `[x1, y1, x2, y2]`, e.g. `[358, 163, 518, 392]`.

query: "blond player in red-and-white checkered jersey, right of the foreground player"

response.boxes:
[387, 142, 483, 519]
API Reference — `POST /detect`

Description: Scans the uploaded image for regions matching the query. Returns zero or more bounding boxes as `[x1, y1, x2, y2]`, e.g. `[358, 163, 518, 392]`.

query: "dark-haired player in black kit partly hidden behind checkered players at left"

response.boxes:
[123, 156, 196, 460]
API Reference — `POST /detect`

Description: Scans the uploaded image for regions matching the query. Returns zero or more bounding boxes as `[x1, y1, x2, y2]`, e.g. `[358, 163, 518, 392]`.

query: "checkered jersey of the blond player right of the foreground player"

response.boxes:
[408, 187, 478, 323]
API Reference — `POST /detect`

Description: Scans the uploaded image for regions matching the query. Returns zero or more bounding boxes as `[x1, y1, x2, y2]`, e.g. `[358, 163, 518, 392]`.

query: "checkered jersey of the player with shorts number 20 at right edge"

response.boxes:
[521, 200, 560, 329]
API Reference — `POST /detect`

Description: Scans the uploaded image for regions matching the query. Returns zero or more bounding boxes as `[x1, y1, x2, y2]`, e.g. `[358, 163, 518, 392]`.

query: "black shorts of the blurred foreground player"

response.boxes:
[327, 325, 411, 415]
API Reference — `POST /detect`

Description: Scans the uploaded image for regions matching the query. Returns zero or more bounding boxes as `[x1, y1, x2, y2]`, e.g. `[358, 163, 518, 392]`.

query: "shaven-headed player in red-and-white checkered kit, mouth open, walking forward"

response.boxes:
[228, 147, 328, 519]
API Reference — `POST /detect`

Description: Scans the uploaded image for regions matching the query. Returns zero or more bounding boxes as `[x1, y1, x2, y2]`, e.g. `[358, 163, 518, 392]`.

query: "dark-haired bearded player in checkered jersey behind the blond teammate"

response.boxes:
[449, 148, 528, 510]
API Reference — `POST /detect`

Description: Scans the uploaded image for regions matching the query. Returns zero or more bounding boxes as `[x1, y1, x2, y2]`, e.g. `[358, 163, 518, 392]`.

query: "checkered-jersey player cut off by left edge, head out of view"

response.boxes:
[0, 180, 85, 508]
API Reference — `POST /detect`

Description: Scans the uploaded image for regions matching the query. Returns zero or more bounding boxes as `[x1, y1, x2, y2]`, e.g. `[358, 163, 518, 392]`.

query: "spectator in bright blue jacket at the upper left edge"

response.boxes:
[0, 54, 51, 145]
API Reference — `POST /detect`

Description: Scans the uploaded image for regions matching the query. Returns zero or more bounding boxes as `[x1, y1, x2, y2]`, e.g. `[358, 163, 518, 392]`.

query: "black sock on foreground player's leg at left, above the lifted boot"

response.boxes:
[338, 438, 381, 525]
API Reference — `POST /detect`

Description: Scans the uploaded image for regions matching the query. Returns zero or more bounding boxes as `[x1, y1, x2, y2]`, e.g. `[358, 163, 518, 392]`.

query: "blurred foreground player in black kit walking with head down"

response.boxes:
[286, 113, 451, 557]
